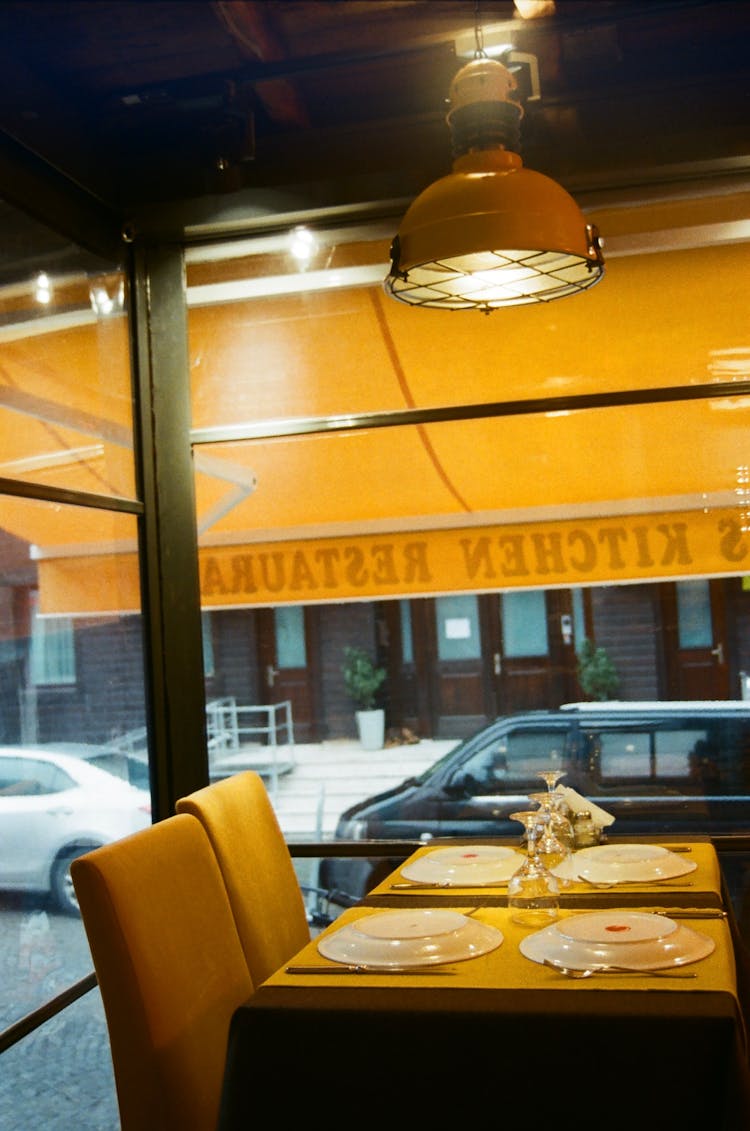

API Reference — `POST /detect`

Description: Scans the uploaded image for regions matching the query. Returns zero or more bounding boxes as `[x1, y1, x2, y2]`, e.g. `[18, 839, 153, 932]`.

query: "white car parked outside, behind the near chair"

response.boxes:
[0, 746, 152, 914]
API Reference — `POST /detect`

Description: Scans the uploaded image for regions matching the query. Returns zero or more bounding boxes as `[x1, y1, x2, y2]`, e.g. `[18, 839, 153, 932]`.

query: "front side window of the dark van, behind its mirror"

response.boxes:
[459, 726, 567, 794]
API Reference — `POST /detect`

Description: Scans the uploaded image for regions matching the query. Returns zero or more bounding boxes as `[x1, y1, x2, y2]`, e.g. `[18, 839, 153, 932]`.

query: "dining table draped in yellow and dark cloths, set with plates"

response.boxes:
[218, 838, 750, 1131]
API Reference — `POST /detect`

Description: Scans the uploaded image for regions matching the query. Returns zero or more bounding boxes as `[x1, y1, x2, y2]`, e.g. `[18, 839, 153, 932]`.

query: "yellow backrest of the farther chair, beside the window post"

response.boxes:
[176, 770, 310, 985]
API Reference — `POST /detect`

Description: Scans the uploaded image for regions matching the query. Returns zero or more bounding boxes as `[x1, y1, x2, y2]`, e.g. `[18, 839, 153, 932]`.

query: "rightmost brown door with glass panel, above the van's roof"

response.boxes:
[662, 578, 730, 699]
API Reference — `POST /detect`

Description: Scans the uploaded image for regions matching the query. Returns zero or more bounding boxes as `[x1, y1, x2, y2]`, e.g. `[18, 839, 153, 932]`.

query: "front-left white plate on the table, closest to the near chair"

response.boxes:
[318, 908, 502, 969]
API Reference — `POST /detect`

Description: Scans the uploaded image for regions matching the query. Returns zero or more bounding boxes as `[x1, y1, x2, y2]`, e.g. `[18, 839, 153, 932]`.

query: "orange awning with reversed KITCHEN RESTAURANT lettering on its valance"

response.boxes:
[0, 198, 750, 613]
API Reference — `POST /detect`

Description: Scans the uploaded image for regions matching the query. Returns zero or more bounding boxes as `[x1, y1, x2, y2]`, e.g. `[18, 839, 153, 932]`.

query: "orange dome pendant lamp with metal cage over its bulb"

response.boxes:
[383, 58, 604, 313]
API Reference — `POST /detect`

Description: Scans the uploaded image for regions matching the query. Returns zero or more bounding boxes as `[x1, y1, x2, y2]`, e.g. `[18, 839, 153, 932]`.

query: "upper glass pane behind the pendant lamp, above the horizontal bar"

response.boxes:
[187, 231, 747, 422]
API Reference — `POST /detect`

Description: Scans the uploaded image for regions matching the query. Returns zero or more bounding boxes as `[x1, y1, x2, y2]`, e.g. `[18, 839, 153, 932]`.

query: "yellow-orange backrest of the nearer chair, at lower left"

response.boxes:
[70, 814, 253, 1131]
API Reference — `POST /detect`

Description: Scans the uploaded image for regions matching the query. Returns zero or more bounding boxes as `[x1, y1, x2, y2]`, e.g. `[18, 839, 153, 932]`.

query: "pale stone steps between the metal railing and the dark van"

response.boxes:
[267, 739, 459, 840]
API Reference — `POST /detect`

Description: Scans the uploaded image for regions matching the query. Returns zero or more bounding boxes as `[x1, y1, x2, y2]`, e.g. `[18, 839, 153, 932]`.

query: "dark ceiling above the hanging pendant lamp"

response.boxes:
[0, 0, 750, 209]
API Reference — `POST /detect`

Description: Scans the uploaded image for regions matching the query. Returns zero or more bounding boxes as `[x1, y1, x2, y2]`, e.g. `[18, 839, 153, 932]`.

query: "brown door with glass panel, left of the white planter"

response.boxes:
[258, 605, 319, 742]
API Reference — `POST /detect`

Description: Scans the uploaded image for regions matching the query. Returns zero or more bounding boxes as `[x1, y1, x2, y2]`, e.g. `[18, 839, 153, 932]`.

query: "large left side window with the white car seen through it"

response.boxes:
[0, 201, 152, 1131]
